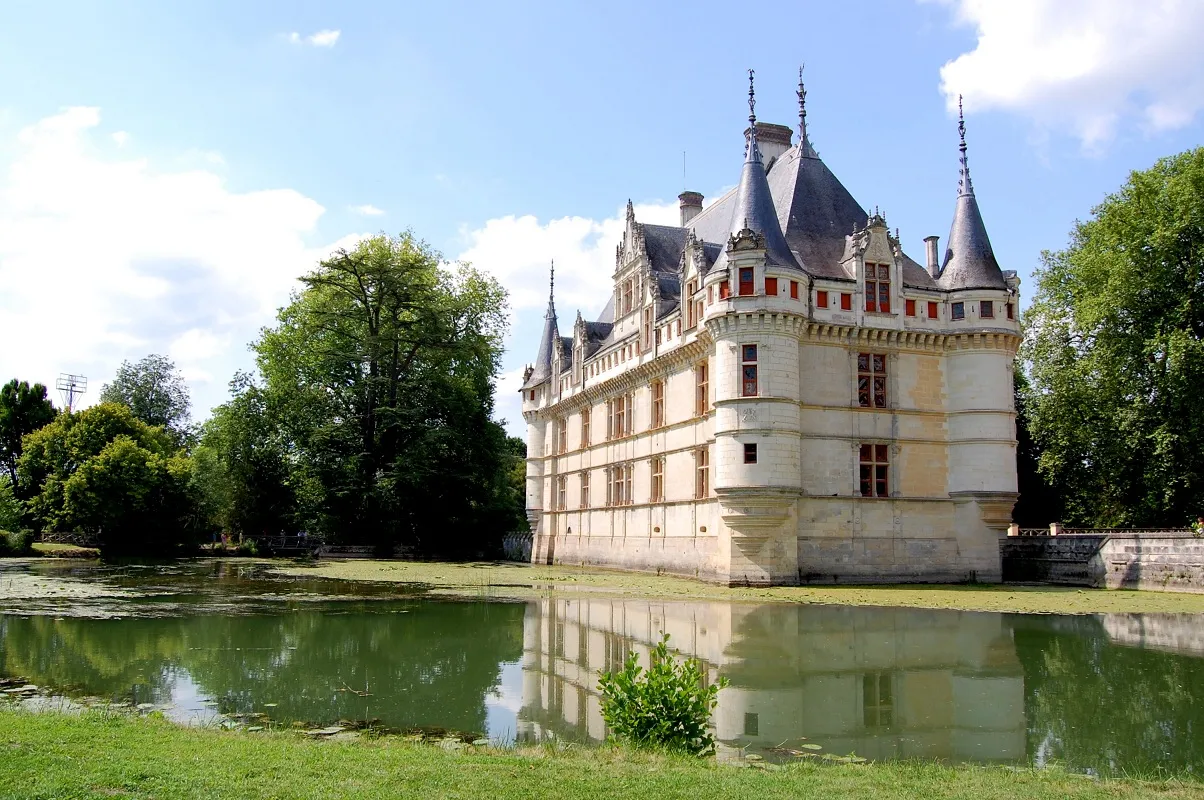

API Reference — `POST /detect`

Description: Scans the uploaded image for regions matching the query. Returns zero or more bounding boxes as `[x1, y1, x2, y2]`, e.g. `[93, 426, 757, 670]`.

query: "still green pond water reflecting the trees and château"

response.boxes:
[0, 561, 1204, 773]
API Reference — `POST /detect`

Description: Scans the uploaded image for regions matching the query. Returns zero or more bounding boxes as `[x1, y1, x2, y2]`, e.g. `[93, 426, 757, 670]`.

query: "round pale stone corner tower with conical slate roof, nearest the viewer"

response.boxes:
[706, 70, 804, 584]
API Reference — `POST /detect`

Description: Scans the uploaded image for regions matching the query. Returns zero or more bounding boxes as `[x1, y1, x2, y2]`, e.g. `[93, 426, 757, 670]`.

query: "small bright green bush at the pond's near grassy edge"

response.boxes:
[598, 634, 727, 755]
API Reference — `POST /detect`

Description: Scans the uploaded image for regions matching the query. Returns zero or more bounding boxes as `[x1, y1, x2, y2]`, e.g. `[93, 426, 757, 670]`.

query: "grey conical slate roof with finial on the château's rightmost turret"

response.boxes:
[939, 95, 1008, 289]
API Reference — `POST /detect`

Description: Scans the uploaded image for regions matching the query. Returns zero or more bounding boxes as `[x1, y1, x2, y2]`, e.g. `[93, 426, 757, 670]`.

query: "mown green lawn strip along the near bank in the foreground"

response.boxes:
[0, 708, 1204, 800]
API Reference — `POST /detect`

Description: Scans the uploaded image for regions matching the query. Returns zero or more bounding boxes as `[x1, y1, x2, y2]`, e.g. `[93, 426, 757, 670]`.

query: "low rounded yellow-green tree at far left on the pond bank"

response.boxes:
[18, 402, 203, 554]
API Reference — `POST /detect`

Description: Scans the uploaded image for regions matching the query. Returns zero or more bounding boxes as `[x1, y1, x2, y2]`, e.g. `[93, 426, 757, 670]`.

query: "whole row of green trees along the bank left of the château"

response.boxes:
[0, 234, 526, 558]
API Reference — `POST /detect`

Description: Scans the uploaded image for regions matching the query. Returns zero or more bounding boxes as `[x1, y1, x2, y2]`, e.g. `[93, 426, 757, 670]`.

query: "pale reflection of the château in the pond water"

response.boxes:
[518, 596, 1026, 761]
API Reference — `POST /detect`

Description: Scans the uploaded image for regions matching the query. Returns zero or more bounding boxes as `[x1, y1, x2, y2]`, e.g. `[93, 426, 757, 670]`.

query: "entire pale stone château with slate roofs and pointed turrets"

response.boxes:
[521, 77, 1020, 584]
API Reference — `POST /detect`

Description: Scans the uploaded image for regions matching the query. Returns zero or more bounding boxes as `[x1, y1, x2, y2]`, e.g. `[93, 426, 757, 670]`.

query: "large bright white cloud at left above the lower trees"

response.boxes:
[0, 107, 356, 417]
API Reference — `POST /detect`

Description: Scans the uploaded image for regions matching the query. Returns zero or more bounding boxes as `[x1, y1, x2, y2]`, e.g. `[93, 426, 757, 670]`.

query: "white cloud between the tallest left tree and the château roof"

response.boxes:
[456, 201, 679, 439]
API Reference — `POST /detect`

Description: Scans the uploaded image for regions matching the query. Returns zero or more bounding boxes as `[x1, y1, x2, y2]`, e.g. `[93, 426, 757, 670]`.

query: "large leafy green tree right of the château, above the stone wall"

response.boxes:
[1022, 148, 1204, 527]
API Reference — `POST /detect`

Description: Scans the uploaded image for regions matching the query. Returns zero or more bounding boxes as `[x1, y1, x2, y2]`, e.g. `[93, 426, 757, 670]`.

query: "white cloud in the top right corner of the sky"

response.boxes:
[936, 0, 1204, 149]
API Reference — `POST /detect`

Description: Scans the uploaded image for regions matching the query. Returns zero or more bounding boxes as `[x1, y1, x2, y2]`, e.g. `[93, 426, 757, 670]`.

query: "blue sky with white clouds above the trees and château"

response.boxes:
[0, 0, 1204, 433]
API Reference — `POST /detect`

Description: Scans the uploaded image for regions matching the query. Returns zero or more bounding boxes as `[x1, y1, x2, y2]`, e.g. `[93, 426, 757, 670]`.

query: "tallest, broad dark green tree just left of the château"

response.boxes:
[242, 234, 514, 555]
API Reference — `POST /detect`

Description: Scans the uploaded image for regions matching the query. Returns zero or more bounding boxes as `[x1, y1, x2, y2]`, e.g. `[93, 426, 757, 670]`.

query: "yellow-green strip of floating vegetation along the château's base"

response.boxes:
[276, 560, 1204, 614]
